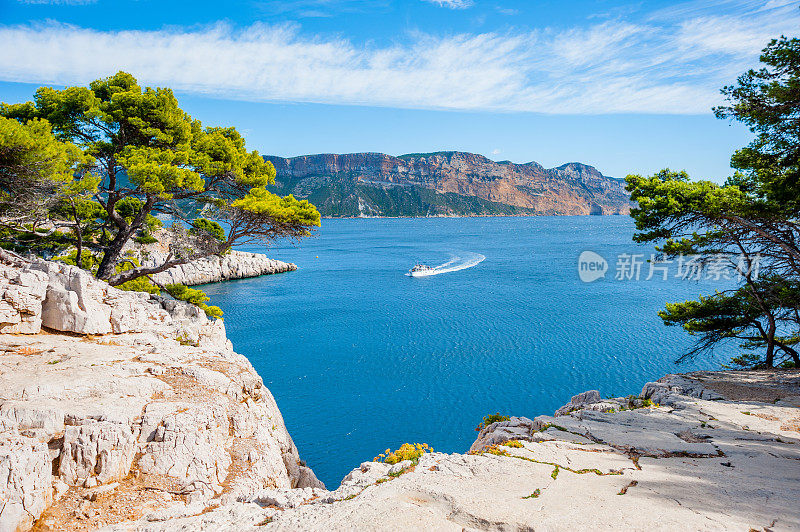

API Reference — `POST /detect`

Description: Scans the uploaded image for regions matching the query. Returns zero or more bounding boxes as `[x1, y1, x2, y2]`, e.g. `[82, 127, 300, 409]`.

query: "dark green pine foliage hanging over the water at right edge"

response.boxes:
[627, 37, 800, 367]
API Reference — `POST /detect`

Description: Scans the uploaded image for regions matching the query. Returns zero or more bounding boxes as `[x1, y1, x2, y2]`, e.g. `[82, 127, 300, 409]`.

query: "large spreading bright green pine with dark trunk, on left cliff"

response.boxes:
[0, 72, 320, 286]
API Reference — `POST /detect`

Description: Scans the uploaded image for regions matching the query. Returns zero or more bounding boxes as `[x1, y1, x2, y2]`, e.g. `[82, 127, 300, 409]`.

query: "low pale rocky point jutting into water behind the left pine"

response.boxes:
[152, 251, 297, 286]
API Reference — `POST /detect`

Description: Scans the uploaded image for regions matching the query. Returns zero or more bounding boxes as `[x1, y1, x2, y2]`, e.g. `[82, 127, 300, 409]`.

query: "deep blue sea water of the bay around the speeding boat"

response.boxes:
[205, 217, 719, 488]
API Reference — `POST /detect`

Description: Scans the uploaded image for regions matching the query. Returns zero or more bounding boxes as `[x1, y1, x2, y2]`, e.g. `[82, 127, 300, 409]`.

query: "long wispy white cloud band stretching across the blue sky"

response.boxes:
[0, 0, 800, 114]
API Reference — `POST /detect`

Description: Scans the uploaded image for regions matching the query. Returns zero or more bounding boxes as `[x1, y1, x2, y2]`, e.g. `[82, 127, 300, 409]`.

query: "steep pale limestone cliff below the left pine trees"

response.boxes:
[0, 252, 322, 531]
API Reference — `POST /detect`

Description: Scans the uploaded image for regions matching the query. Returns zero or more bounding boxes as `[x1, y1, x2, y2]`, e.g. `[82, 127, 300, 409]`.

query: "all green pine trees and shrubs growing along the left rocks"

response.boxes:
[0, 72, 320, 316]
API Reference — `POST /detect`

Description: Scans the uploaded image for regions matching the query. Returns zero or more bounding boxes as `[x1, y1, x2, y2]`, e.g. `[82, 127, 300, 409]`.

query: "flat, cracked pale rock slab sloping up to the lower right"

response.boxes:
[110, 371, 800, 531]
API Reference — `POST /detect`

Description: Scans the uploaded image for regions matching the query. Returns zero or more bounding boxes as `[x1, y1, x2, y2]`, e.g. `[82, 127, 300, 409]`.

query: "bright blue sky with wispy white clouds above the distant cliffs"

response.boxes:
[0, 0, 800, 181]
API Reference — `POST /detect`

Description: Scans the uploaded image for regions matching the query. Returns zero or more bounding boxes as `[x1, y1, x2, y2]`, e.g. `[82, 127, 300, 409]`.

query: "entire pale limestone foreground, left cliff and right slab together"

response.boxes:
[0, 252, 800, 532]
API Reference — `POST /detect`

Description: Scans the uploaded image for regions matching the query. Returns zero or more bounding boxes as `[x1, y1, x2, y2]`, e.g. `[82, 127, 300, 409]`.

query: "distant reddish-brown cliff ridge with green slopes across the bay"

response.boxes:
[265, 151, 630, 217]
